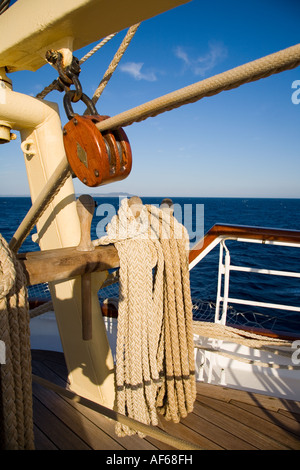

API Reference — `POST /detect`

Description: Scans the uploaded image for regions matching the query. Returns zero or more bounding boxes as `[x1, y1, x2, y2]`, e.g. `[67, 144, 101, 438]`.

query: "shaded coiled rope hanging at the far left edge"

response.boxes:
[0, 236, 34, 450]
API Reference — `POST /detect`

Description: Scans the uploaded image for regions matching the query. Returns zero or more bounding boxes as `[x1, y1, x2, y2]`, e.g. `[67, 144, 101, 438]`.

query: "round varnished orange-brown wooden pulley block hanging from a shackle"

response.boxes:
[63, 114, 132, 187]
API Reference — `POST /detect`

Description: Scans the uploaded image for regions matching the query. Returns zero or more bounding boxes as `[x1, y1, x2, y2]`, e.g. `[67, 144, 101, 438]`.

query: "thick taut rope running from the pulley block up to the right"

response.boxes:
[96, 44, 300, 132]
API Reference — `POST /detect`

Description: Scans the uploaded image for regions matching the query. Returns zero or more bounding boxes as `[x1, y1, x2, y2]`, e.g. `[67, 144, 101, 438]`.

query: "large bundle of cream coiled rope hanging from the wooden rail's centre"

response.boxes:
[94, 199, 196, 436]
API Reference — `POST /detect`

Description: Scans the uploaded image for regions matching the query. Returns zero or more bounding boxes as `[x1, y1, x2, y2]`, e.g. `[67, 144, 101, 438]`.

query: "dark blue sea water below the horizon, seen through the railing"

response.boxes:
[0, 196, 300, 333]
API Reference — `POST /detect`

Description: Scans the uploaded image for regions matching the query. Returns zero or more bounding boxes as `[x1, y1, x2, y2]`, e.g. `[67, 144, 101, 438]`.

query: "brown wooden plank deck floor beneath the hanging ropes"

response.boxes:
[32, 351, 300, 452]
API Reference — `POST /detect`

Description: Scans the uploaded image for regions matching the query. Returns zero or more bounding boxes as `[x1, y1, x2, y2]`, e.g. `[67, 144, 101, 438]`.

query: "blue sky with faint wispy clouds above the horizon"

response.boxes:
[0, 0, 300, 198]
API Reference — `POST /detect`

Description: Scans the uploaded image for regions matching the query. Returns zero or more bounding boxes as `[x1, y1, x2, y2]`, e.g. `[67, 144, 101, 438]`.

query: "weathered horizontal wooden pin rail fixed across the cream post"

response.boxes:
[17, 245, 119, 286]
